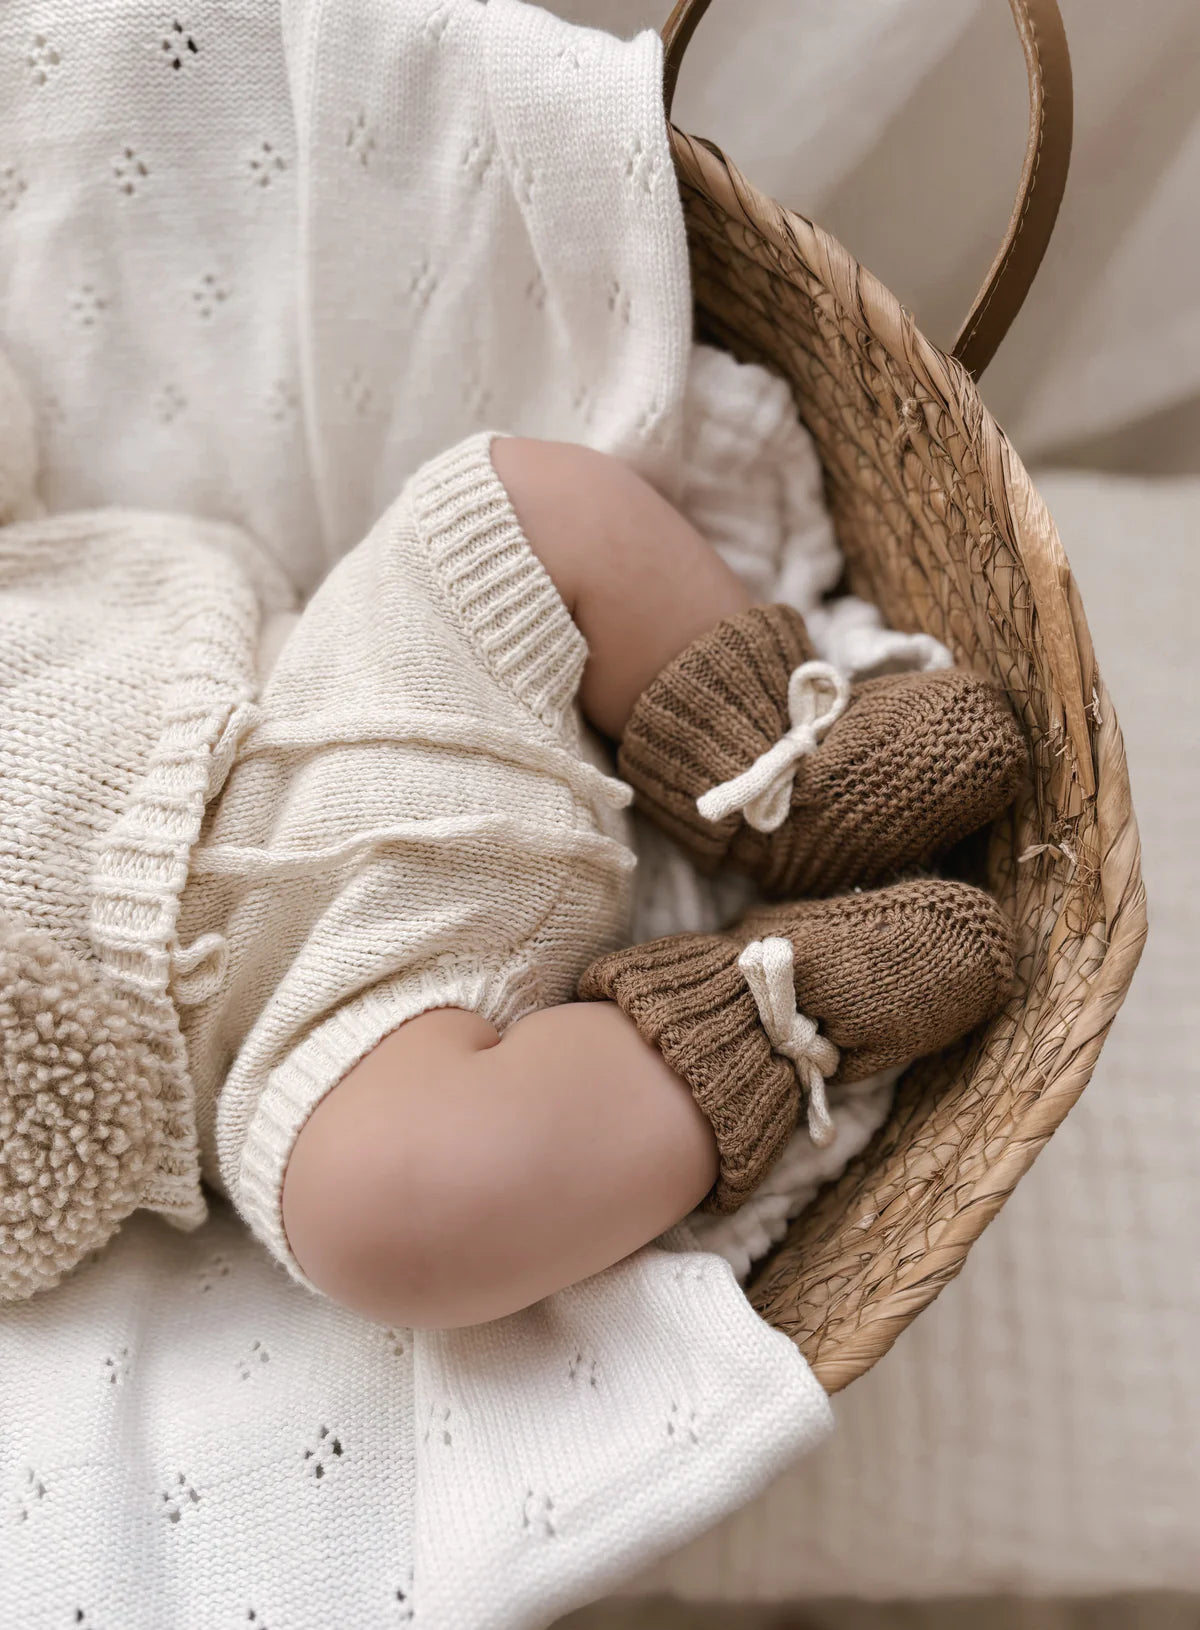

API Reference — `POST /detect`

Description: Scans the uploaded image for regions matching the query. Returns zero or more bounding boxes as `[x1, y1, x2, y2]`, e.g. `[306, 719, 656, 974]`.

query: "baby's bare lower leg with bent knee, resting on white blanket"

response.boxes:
[282, 1002, 717, 1328]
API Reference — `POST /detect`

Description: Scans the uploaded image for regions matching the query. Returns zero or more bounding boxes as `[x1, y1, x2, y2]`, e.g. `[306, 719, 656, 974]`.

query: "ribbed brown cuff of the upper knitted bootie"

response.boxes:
[616, 605, 815, 872]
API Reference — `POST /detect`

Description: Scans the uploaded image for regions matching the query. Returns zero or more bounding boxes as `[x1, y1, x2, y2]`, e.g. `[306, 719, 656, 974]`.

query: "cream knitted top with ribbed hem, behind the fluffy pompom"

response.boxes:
[0, 510, 293, 1227]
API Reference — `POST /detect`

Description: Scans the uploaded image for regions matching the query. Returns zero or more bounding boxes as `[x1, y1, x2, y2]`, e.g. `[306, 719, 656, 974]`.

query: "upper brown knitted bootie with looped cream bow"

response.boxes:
[618, 606, 1027, 898]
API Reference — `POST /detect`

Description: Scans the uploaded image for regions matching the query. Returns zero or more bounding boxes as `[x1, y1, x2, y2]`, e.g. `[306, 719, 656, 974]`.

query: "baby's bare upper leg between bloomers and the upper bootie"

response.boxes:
[492, 437, 753, 740]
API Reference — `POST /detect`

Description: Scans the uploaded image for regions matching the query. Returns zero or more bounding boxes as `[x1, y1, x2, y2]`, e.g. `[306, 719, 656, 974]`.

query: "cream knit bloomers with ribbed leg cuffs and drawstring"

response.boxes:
[173, 434, 634, 1284]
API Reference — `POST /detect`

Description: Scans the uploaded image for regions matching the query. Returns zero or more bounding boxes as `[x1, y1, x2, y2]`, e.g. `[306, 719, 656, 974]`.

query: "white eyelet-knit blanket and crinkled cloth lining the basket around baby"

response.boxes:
[0, 0, 946, 1630]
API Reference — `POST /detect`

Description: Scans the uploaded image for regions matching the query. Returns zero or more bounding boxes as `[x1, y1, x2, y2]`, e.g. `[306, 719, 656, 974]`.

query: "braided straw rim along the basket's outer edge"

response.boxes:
[670, 126, 1146, 1392]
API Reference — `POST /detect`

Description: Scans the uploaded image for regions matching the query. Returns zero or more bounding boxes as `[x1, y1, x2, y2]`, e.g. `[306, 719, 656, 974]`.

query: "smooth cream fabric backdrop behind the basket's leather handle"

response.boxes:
[551, 0, 1200, 473]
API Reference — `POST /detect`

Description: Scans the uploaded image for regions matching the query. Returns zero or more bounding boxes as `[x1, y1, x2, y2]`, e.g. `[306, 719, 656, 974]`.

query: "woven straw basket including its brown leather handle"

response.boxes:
[664, 0, 1146, 1392]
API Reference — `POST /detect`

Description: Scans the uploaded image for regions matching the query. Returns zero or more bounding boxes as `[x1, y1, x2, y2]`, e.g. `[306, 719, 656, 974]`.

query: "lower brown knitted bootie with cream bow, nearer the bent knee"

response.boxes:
[579, 879, 1014, 1213]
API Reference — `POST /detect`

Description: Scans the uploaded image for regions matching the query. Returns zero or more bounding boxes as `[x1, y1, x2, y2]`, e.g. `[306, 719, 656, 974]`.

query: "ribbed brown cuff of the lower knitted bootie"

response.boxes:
[579, 934, 799, 1213]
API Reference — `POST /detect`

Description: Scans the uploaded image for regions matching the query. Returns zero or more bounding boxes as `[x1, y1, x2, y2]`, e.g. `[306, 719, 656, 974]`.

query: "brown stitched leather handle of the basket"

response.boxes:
[662, 0, 1073, 380]
